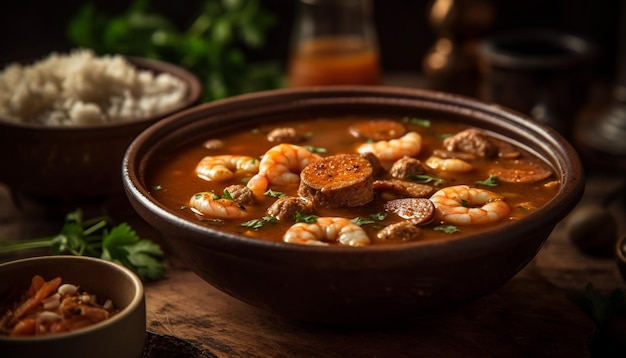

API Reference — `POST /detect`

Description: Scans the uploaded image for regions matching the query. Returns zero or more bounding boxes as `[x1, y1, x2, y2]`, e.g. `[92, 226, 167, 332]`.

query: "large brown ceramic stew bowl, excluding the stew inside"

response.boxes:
[123, 86, 584, 323]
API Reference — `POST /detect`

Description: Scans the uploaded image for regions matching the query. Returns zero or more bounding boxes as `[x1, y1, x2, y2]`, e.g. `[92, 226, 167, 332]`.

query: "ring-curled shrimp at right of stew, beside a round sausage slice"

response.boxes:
[430, 185, 511, 225]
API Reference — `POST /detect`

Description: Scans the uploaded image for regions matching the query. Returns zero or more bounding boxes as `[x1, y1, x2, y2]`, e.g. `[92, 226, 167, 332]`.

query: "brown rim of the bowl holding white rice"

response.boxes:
[0, 56, 202, 137]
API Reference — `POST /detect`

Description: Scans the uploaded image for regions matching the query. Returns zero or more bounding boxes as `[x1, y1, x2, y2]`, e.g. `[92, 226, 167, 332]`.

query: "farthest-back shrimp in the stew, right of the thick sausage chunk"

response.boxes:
[358, 132, 422, 161]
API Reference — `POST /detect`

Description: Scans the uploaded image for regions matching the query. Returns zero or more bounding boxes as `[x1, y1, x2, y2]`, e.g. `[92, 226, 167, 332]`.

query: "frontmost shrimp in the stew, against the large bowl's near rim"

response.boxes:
[283, 217, 370, 246]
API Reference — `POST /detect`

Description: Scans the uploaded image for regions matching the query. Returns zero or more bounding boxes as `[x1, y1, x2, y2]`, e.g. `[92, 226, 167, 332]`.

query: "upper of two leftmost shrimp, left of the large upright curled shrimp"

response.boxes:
[196, 154, 259, 181]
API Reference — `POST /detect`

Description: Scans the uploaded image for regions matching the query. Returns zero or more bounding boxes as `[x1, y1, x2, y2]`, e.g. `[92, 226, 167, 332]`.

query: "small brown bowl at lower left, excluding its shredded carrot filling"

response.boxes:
[0, 256, 146, 358]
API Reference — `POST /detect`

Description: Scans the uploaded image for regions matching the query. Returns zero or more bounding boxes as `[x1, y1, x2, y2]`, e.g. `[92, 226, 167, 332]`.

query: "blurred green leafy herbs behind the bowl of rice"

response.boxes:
[67, 0, 284, 102]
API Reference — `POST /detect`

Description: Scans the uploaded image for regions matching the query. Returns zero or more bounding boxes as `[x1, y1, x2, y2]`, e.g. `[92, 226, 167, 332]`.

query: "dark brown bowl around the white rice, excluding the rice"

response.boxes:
[0, 54, 202, 210]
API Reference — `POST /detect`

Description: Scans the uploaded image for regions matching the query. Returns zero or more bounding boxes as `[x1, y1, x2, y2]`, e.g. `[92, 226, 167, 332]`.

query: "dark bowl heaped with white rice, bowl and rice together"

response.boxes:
[0, 49, 202, 207]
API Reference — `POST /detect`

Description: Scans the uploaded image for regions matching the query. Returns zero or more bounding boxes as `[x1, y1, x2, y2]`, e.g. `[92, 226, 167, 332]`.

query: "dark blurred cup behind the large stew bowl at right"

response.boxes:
[480, 30, 596, 138]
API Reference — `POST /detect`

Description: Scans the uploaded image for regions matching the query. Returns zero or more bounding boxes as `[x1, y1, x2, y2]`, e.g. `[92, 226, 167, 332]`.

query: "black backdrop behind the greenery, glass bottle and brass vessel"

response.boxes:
[0, 0, 620, 79]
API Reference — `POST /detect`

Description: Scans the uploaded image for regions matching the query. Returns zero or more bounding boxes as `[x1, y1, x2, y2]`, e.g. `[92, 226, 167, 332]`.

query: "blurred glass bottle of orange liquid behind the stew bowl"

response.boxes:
[287, 0, 381, 87]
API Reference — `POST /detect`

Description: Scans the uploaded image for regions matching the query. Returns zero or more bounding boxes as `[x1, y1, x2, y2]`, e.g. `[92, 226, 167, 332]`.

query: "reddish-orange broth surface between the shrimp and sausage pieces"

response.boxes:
[147, 117, 560, 245]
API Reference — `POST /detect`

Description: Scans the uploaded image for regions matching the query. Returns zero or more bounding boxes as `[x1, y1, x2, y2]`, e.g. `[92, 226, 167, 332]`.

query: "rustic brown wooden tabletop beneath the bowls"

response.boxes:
[0, 77, 626, 357]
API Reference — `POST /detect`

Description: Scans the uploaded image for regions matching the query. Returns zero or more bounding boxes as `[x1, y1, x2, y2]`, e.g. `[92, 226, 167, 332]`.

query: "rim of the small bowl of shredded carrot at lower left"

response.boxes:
[0, 255, 144, 342]
